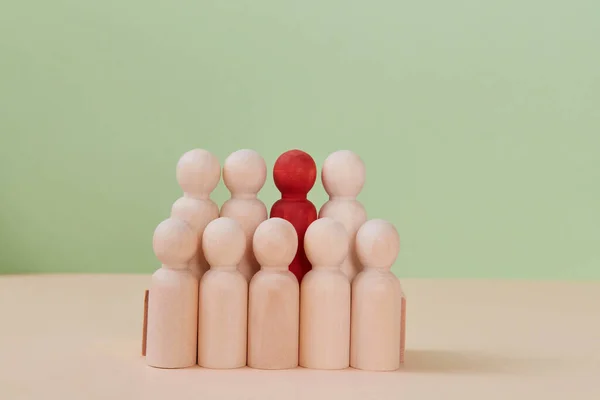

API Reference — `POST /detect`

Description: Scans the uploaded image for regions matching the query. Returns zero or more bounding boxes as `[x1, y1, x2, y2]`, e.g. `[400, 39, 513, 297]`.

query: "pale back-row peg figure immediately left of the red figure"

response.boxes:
[220, 149, 267, 282]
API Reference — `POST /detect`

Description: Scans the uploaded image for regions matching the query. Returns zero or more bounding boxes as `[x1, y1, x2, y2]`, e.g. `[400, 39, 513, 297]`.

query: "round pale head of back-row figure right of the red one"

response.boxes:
[321, 150, 366, 197]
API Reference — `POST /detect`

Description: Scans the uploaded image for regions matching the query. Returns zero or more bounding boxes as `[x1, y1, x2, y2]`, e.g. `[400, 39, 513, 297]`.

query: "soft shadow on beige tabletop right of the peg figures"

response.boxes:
[402, 349, 560, 375]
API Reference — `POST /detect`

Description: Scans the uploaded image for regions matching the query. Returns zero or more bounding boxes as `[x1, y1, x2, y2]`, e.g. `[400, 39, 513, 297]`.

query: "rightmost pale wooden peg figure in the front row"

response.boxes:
[350, 219, 402, 371]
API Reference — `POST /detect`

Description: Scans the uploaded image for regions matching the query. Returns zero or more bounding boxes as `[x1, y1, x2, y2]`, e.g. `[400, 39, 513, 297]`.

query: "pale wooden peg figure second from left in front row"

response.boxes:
[198, 218, 248, 369]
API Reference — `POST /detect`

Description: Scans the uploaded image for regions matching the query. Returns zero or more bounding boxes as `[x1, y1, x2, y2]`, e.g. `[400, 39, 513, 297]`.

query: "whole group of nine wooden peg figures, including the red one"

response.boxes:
[143, 149, 406, 371]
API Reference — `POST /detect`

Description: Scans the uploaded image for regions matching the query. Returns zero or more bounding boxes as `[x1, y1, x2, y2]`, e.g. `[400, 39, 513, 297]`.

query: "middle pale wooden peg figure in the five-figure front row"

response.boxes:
[248, 218, 300, 370]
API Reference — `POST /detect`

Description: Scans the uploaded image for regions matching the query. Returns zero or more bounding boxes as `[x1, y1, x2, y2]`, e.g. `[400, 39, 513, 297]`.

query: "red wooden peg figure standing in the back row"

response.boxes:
[270, 150, 317, 283]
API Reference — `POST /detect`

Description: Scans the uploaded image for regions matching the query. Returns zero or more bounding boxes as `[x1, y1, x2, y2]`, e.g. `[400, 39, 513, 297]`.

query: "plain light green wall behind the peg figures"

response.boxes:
[0, 0, 600, 279]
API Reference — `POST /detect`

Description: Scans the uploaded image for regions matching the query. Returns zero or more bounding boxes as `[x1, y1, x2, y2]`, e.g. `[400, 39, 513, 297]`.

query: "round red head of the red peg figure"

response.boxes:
[273, 150, 317, 196]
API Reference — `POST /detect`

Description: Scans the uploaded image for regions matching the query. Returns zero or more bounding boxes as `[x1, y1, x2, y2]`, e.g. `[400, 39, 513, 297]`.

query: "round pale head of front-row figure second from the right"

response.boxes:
[304, 218, 349, 268]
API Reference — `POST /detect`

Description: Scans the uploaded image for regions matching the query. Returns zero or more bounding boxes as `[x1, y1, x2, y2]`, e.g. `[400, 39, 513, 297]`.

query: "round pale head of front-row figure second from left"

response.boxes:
[202, 217, 246, 268]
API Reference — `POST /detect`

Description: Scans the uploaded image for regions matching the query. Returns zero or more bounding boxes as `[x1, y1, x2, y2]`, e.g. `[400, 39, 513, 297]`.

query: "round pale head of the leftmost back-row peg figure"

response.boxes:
[176, 149, 221, 198]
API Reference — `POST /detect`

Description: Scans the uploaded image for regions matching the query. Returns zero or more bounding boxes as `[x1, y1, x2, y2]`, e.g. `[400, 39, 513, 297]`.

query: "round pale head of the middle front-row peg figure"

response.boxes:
[252, 218, 298, 268]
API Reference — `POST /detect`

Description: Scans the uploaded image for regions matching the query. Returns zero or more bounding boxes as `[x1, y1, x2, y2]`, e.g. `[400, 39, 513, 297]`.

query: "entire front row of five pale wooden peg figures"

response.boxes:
[146, 217, 404, 371]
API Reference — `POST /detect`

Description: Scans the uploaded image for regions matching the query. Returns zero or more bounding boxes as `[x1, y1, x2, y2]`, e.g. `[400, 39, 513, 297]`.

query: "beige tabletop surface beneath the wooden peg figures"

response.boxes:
[0, 275, 600, 400]
